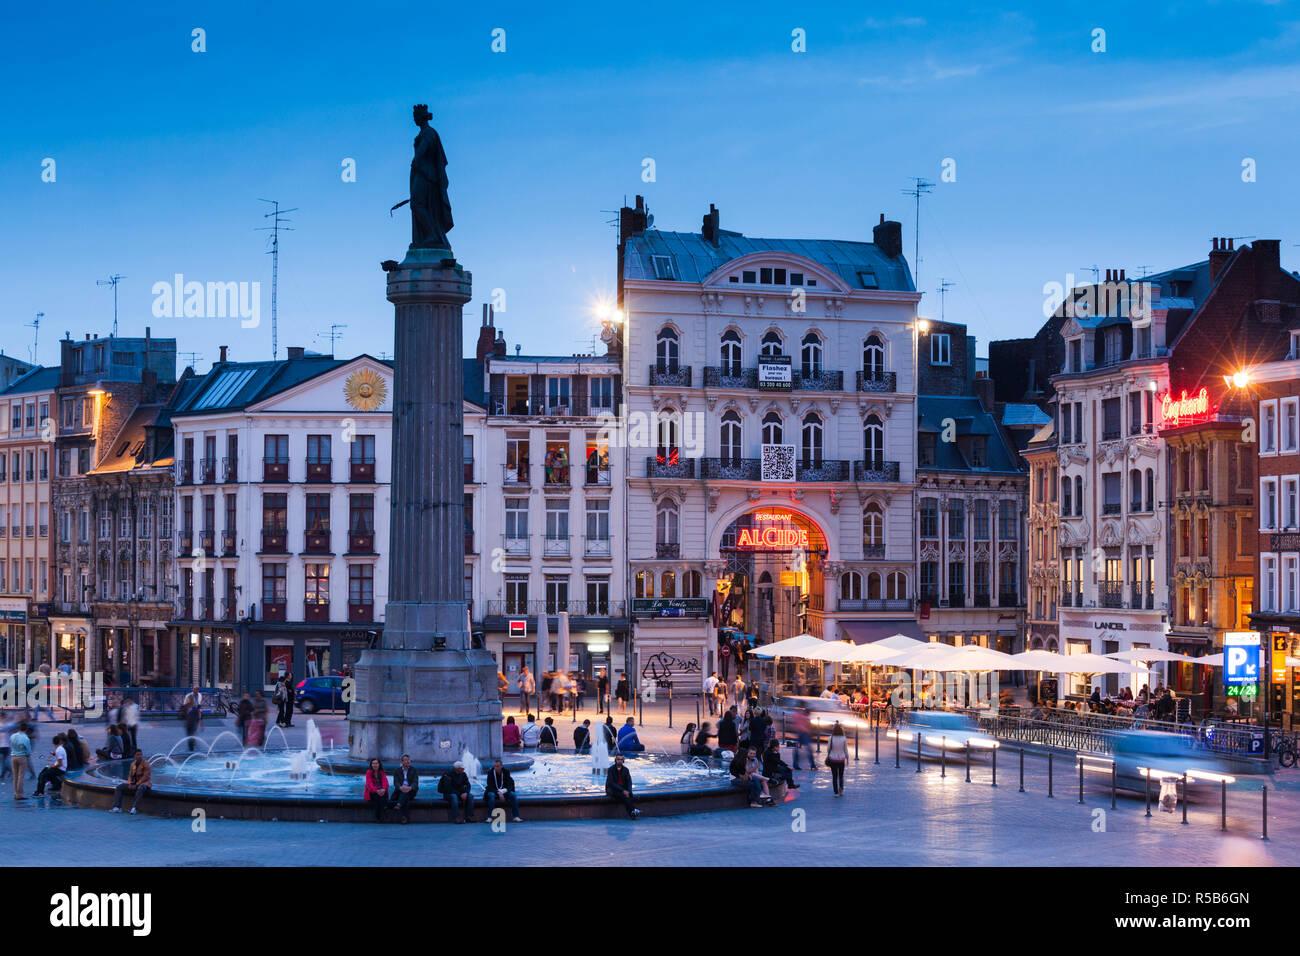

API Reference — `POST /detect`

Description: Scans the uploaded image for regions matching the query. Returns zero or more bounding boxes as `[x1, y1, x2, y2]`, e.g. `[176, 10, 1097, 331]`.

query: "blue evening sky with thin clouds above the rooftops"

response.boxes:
[0, 0, 1300, 371]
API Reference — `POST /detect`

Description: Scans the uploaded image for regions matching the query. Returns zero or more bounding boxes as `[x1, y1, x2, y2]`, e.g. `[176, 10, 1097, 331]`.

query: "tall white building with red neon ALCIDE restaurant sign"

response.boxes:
[619, 199, 919, 692]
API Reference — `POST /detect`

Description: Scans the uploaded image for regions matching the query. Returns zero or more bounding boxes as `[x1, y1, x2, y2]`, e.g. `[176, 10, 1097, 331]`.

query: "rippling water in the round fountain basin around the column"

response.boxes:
[62, 750, 748, 823]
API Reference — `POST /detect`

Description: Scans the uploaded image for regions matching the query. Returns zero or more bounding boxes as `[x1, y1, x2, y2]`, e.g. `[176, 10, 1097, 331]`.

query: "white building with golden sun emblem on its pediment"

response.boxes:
[170, 347, 393, 691]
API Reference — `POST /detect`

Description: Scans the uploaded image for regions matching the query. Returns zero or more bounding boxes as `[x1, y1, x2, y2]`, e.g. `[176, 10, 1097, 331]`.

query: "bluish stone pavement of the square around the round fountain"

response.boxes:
[0, 702, 1300, 866]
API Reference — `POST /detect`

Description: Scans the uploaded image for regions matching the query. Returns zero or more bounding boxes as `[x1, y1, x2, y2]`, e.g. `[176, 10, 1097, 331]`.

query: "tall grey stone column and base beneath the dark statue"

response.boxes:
[335, 248, 529, 770]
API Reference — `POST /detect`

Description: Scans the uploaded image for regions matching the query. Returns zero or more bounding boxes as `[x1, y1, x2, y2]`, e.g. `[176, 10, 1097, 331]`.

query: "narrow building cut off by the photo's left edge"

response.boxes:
[0, 367, 59, 670]
